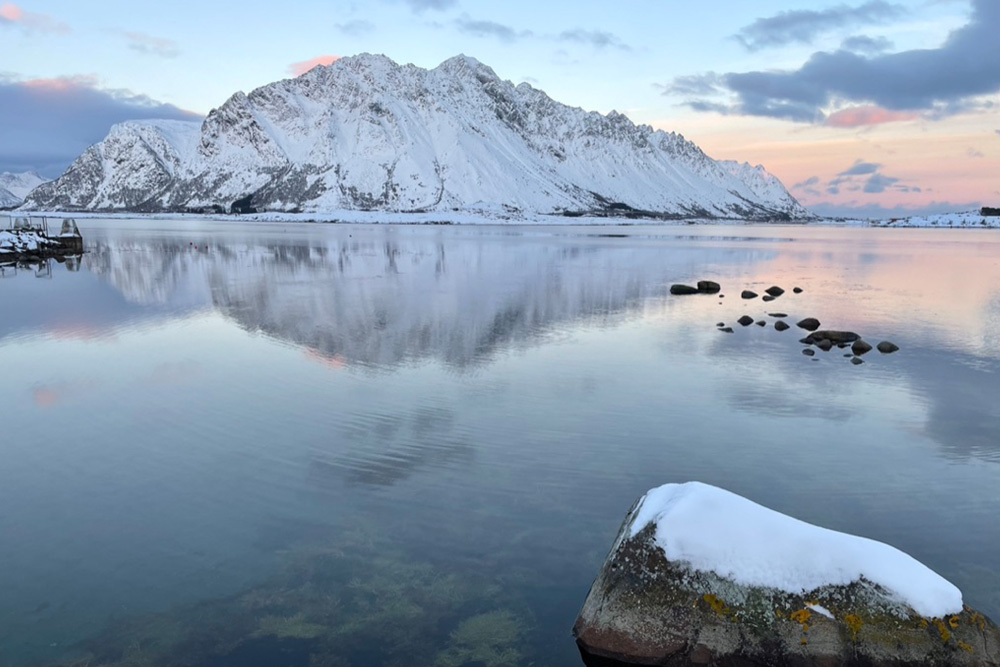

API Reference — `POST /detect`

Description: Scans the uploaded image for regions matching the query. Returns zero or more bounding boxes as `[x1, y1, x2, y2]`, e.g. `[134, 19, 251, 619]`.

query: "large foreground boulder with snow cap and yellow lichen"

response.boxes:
[574, 482, 1000, 665]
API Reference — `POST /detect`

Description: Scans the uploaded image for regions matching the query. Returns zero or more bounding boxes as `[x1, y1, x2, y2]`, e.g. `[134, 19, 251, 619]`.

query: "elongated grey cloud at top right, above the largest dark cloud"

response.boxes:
[734, 0, 904, 51]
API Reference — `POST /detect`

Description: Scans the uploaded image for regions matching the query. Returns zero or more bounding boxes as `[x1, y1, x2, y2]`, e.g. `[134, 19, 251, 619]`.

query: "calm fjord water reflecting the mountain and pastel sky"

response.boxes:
[0, 220, 1000, 665]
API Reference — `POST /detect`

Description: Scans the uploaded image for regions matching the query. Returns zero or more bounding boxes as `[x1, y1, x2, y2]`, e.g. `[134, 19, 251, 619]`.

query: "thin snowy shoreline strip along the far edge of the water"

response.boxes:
[10, 210, 1000, 229]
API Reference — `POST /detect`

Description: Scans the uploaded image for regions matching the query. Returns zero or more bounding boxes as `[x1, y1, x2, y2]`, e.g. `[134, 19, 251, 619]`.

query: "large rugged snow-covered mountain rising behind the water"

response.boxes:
[26, 54, 809, 218]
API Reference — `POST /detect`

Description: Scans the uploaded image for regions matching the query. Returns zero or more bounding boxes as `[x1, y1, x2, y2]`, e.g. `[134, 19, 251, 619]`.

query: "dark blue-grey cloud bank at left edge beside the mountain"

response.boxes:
[0, 77, 200, 177]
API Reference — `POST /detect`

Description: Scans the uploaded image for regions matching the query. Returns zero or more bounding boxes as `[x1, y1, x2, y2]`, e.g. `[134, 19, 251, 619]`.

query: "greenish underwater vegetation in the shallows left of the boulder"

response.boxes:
[41, 532, 532, 667]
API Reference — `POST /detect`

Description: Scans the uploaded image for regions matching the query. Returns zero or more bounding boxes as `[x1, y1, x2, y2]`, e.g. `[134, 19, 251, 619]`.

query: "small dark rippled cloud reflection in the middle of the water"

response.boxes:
[310, 408, 475, 486]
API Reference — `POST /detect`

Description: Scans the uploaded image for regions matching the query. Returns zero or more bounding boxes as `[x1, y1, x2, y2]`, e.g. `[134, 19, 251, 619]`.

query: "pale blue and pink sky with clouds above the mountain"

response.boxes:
[0, 0, 1000, 216]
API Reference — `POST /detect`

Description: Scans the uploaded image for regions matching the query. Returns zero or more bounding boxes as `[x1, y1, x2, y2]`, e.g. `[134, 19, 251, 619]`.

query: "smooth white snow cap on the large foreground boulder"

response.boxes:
[630, 482, 963, 618]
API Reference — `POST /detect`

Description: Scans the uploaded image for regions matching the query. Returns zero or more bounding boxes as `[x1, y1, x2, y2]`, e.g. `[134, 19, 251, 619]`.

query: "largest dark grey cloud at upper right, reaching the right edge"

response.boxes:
[680, 0, 1000, 123]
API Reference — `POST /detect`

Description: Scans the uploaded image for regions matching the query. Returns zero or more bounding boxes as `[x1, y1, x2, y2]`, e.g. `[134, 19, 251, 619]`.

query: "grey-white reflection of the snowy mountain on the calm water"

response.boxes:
[85, 228, 728, 368]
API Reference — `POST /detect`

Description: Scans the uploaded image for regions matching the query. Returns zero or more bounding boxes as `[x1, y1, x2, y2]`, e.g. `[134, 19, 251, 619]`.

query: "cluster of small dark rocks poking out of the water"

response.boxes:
[670, 280, 899, 366]
